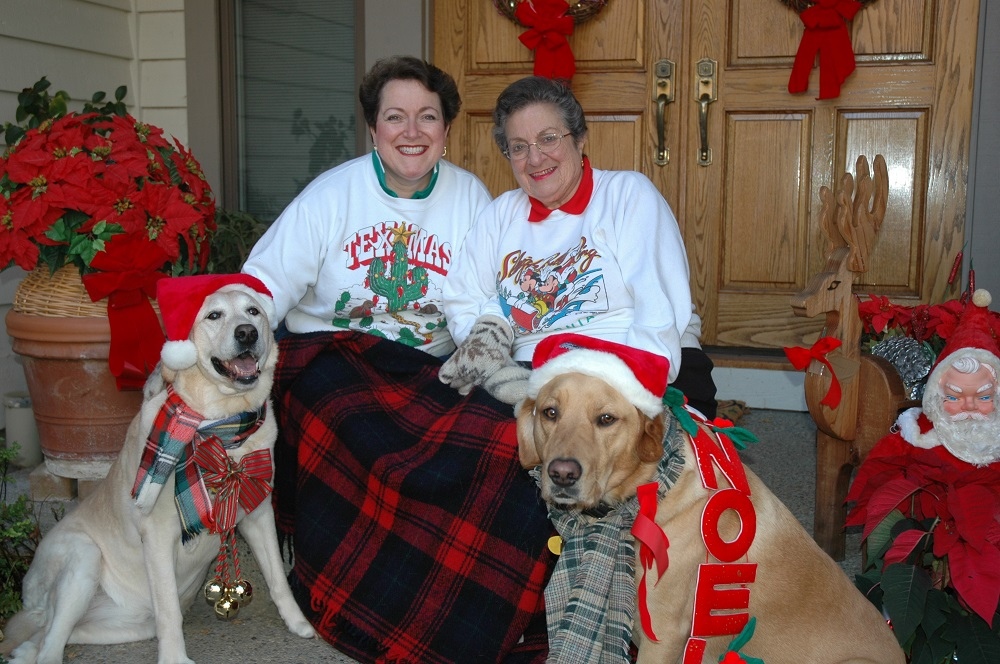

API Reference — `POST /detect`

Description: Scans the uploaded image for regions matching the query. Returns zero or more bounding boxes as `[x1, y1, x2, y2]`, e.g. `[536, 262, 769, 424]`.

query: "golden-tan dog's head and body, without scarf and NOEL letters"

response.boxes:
[517, 335, 904, 664]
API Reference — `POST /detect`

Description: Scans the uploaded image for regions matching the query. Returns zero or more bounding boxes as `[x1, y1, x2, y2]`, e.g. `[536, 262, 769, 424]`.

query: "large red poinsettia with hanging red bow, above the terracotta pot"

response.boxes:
[0, 77, 216, 388]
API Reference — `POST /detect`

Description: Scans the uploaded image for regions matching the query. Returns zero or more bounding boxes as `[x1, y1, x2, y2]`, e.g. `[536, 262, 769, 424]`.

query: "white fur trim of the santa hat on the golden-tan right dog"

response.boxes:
[528, 348, 663, 417]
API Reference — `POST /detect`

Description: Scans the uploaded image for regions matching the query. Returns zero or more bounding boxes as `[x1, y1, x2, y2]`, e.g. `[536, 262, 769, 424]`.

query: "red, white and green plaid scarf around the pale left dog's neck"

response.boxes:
[132, 385, 266, 542]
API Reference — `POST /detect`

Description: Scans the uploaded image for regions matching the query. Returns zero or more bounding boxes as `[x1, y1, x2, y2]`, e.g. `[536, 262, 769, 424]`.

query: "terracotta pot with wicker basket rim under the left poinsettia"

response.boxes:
[6, 267, 148, 479]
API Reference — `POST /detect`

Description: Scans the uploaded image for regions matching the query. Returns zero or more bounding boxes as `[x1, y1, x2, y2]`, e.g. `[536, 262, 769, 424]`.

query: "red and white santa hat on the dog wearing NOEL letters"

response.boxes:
[528, 334, 670, 417]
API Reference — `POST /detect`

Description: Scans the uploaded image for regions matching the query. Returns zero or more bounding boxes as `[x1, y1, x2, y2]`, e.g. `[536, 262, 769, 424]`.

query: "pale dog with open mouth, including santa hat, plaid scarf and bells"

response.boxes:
[0, 274, 315, 664]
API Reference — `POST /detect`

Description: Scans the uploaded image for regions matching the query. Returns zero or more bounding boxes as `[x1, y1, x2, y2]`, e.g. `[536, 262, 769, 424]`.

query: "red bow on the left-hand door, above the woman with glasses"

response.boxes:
[514, 0, 576, 81]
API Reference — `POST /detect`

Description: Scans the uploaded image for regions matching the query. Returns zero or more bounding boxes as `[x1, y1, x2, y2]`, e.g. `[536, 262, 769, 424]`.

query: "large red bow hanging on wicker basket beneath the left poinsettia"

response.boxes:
[83, 235, 167, 390]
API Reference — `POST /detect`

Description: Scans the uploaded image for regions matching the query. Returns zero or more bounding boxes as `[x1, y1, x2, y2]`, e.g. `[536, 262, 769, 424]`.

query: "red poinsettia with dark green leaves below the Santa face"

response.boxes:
[847, 439, 1000, 664]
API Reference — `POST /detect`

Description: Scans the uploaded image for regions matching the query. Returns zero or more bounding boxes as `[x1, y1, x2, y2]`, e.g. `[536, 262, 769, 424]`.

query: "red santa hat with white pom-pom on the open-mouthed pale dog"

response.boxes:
[156, 274, 274, 371]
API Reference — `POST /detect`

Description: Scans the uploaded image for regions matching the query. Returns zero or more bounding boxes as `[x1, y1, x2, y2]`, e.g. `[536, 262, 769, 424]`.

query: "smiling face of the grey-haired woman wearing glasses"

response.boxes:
[504, 102, 586, 210]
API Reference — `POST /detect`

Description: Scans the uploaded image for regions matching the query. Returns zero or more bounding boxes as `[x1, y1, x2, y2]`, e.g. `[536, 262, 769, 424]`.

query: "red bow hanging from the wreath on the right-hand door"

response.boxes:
[788, 0, 861, 99]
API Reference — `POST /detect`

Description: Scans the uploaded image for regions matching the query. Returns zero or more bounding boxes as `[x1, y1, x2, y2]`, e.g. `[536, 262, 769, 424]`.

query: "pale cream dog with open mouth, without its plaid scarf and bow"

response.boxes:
[2, 275, 315, 664]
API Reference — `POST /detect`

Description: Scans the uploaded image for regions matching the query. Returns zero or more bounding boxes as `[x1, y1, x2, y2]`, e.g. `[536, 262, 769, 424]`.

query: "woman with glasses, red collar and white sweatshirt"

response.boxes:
[440, 76, 717, 418]
